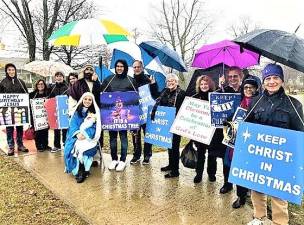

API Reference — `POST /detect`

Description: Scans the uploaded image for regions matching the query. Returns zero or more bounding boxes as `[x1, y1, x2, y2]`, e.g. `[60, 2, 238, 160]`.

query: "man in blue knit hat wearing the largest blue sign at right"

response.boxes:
[245, 64, 304, 225]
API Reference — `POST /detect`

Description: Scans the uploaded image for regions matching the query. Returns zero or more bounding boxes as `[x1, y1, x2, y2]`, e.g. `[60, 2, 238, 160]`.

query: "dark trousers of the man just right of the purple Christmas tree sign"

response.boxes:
[132, 124, 152, 159]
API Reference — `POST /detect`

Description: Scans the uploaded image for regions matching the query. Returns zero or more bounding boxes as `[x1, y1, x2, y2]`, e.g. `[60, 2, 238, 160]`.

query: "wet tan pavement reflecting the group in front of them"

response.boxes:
[0, 134, 252, 225]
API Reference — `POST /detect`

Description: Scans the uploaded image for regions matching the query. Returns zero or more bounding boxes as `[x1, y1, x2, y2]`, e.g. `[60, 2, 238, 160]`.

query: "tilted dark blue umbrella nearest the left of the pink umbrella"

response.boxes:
[139, 41, 187, 72]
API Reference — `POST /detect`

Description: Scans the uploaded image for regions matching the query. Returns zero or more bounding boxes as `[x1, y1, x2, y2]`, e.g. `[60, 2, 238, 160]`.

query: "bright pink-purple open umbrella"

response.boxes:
[192, 40, 260, 69]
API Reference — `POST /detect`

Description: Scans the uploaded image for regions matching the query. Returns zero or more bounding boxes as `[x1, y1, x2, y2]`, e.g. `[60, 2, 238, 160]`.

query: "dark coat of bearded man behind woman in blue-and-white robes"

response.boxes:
[68, 78, 101, 106]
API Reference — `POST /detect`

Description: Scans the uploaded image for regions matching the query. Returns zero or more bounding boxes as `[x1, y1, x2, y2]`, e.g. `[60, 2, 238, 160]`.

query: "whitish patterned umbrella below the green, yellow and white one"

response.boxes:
[23, 61, 75, 77]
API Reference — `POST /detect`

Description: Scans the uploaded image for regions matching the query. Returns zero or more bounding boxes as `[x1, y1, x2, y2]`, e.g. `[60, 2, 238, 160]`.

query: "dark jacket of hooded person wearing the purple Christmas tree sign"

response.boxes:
[101, 74, 137, 92]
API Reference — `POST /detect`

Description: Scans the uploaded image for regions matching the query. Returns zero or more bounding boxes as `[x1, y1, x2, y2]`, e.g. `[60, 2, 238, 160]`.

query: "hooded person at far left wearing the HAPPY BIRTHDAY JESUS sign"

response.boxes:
[0, 63, 28, 156]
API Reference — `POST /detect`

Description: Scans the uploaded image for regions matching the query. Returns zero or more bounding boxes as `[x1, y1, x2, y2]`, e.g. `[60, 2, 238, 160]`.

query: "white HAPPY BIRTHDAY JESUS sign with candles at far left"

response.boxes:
[0, 94, 30, 126]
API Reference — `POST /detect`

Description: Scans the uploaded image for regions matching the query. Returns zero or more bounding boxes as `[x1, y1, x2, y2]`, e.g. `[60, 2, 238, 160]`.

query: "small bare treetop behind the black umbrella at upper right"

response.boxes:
[227, 16, 260, 38]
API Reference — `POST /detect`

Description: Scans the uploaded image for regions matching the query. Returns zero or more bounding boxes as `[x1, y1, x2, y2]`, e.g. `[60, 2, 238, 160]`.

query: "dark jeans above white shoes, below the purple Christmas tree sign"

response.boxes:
[109, 130, 128, 162]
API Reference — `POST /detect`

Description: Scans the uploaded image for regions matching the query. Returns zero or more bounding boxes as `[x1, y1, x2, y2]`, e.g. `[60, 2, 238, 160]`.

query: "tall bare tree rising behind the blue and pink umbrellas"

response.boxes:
[150, 0, 213, 72]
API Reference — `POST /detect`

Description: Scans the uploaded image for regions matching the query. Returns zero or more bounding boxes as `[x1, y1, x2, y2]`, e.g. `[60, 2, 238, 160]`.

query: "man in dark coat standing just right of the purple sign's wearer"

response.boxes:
[130, 60, 159, 165]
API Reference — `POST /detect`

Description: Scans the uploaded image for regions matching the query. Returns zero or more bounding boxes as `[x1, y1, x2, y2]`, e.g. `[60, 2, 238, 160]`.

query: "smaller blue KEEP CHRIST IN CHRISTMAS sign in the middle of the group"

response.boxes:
[145, 106, 176, 148]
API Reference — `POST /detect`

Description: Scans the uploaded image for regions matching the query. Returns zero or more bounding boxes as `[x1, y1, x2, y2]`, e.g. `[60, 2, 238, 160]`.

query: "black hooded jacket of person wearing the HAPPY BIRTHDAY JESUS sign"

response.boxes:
[0, 75, 28, 93]
